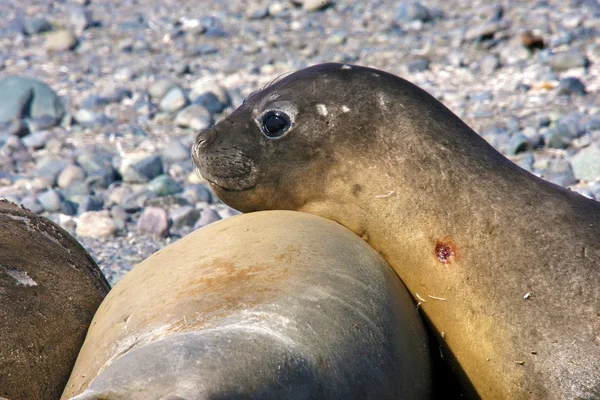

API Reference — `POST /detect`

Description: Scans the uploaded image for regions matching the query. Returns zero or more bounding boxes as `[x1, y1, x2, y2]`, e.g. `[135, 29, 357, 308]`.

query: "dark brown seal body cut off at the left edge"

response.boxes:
[0, 201, 109, 400]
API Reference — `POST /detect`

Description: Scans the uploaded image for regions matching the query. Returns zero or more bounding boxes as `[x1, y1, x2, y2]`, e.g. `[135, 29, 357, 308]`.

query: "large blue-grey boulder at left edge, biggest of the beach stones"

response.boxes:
[0, 76, 65, 123]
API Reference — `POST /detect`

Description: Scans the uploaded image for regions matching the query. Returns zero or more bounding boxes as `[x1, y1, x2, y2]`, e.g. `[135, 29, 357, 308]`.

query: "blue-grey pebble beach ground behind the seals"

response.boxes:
[0, 0, 600, 284]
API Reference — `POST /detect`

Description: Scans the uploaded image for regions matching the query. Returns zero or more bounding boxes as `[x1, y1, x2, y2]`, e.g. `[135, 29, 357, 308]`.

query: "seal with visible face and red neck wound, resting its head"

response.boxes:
[193, 64, 600, 399]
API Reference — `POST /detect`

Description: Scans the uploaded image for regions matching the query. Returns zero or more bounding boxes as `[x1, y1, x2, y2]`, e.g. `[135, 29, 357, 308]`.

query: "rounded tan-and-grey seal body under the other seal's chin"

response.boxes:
[63, 211, 431, 400]
